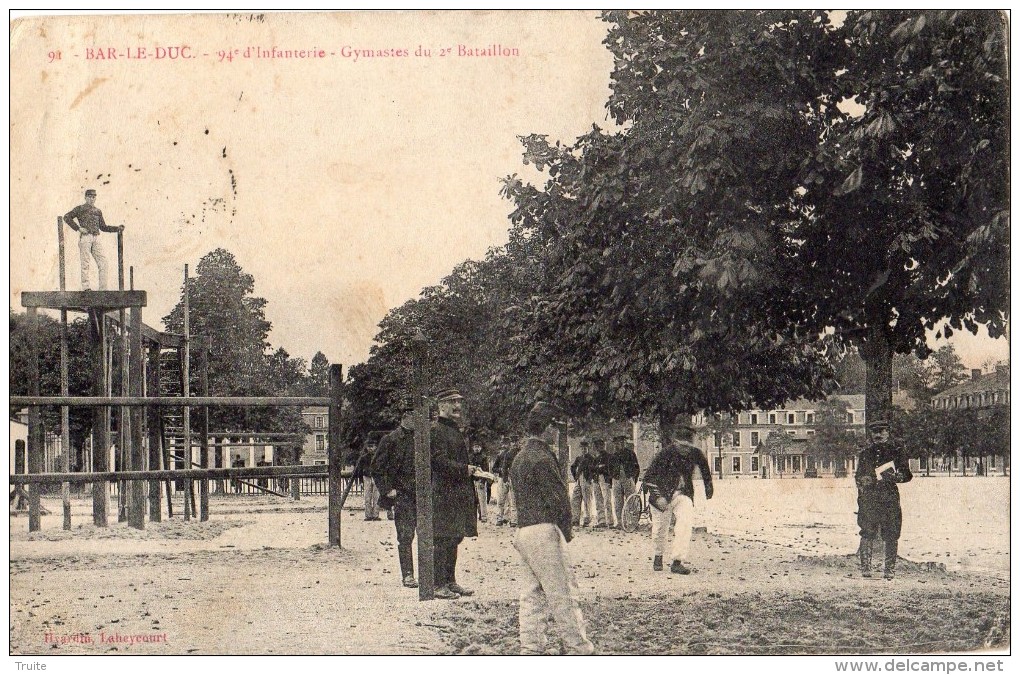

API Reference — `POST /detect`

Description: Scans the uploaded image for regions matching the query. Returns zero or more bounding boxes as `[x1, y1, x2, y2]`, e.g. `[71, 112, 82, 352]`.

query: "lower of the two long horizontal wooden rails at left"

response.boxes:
[10, 464, 338, 485]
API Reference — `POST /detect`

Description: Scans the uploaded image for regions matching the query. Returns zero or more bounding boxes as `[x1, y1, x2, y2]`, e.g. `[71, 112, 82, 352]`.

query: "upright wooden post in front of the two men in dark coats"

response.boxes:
[412, 334, 436, 601]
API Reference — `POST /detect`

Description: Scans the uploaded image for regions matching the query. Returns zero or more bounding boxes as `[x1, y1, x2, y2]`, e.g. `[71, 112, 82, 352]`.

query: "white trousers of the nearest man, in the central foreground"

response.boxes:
[514, 523, 595, 654]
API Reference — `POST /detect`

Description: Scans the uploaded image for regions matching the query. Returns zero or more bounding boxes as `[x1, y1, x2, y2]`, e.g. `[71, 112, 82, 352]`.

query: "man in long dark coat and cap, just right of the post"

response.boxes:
[431, 390, 478, 600]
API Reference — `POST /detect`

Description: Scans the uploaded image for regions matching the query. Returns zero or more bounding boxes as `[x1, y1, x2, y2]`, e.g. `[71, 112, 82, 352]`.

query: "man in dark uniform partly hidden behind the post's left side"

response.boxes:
[372, 410, 418, 588]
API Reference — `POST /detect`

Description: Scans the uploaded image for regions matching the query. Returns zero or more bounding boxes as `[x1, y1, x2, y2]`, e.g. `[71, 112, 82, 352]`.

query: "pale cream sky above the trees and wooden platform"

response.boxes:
[10, 11, 1008, 367]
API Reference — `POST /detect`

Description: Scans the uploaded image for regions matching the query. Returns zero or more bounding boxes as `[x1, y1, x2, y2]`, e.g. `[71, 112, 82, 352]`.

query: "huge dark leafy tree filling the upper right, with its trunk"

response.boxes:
[497, 10, 1009, 418]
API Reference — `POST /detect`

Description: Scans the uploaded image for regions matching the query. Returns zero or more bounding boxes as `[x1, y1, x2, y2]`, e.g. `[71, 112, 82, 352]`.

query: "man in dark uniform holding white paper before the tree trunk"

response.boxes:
[855, 420, 914, 579]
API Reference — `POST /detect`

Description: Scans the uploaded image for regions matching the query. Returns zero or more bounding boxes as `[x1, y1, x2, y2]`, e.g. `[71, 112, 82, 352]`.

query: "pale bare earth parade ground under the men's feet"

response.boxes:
[10, 477, 1010, 655]
